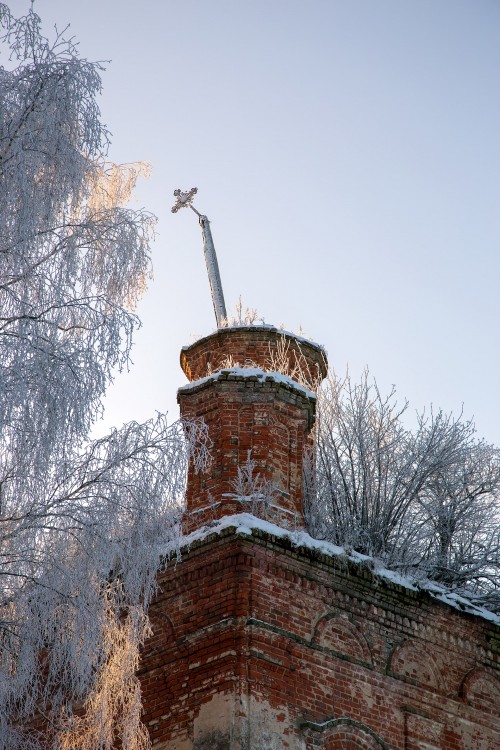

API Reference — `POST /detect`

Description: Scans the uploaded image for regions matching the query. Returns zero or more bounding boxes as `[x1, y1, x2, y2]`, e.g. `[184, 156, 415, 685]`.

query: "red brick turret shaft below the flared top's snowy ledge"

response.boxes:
[178, 371, 315, 528]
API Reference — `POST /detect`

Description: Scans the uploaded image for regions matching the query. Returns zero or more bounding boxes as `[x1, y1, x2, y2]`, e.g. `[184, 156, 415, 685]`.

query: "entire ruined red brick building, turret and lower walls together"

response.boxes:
[139, 326, 500, 750]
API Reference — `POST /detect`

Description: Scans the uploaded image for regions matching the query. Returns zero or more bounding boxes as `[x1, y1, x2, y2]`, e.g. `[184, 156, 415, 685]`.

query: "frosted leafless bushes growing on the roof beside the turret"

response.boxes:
[305, 372, 500, 610]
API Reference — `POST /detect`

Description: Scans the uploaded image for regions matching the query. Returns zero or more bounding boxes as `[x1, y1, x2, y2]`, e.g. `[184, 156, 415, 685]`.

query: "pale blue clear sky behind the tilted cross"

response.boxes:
[8, 0, 500, 445]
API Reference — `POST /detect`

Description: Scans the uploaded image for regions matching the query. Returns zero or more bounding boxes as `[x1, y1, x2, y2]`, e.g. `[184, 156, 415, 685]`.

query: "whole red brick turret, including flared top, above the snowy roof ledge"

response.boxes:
[178, 326, 326, 531]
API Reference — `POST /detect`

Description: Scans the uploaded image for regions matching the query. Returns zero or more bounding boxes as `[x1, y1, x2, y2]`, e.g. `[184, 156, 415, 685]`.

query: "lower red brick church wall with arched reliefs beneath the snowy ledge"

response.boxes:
[141, 530, 500, 750]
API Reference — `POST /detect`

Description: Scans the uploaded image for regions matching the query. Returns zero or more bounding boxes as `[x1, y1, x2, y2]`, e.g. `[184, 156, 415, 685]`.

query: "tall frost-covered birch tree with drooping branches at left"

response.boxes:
[0, 3, 207, 750]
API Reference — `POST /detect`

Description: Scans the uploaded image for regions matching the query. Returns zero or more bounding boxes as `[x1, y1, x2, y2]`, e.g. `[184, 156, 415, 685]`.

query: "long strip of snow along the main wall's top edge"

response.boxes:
[180, 513, 500, 625]
